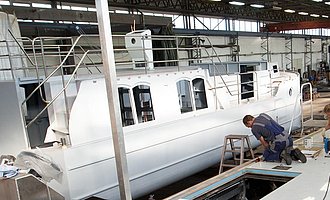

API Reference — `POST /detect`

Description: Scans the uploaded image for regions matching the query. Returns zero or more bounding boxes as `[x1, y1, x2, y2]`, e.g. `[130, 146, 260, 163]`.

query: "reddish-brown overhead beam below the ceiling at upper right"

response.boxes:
[260, 20, 330, 32]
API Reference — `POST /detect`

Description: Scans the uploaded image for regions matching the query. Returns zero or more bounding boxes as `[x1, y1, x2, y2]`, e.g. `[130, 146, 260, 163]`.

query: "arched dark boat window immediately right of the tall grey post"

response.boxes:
[118, 87, 134, 126]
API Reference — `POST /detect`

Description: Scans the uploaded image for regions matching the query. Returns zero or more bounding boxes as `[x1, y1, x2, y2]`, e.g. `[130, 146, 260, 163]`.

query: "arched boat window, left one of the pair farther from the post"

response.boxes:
[176, 80, 193, 113]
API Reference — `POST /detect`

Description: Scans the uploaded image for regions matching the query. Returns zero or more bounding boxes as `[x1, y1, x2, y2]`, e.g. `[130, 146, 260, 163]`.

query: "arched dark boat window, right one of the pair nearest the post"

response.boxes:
[133, 85, 155, 123]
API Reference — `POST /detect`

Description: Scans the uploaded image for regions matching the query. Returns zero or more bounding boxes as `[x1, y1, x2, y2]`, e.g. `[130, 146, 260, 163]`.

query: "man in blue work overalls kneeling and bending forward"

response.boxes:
[243, 113, 307, 165]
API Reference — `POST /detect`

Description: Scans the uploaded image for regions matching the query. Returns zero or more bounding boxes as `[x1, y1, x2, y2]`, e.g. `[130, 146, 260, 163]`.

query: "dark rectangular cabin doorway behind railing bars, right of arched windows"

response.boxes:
[240, 65, 255, 99]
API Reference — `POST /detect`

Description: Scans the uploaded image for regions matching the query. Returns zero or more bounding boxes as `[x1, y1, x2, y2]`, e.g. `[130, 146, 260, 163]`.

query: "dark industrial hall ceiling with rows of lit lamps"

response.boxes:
[1, 0, 330, 36]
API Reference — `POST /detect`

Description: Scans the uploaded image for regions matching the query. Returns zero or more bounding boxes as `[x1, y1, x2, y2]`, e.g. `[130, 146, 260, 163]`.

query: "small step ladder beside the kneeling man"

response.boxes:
[219, 135, 254, 174]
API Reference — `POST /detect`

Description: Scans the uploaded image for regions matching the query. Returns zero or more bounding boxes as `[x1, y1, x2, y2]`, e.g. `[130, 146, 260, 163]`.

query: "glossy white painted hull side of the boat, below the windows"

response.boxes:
[46, 74, 300, 199]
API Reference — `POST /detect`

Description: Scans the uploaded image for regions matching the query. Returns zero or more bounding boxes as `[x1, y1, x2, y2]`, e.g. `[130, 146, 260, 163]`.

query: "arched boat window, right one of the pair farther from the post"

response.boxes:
[193, 78, 207, 110]
